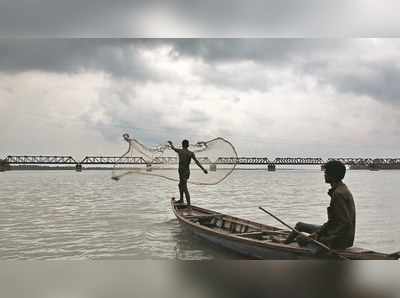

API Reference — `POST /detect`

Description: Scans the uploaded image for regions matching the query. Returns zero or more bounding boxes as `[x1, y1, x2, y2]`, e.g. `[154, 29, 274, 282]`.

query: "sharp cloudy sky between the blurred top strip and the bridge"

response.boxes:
[0, 39, 400, 157]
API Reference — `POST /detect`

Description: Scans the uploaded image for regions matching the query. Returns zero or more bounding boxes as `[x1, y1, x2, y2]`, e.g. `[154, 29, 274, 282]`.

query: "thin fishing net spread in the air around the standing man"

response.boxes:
[111, 134, 238, 185]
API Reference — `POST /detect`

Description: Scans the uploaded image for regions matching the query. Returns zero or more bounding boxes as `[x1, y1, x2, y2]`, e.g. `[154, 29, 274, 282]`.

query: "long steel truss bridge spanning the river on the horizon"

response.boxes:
[0, 155, 400, 171]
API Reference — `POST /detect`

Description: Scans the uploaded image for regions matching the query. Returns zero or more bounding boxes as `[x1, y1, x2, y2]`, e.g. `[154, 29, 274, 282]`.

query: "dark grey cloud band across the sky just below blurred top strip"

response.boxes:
[0, 39, 400, 103]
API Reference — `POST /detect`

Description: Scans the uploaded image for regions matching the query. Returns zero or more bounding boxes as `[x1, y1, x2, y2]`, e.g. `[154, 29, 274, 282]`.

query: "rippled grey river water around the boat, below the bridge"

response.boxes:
[0, 168, 400, 260]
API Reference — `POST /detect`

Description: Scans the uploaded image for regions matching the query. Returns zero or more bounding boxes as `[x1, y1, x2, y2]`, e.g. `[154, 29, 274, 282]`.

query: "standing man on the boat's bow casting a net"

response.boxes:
[168, 140, 208, 206]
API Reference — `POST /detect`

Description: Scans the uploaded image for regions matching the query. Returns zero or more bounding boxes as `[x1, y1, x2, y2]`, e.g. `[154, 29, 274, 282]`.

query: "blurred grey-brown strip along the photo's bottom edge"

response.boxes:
[0, 260, 400, 298]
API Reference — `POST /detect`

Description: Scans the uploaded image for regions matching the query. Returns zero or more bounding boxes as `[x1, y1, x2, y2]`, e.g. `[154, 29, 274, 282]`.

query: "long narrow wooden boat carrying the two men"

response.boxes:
[171, 198, 400, 260]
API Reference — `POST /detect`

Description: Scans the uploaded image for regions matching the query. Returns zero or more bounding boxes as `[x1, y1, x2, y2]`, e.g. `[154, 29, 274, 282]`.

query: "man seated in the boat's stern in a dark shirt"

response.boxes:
[285, 160, 356, 249]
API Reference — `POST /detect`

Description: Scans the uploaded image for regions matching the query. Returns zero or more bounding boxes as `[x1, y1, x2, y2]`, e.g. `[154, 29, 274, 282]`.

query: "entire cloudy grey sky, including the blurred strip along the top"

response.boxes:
[0, 0, 400, 159]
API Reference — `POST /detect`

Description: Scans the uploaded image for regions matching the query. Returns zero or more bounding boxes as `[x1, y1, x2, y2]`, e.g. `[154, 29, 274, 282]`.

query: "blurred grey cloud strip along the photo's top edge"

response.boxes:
[0, 0, 399, 37]
